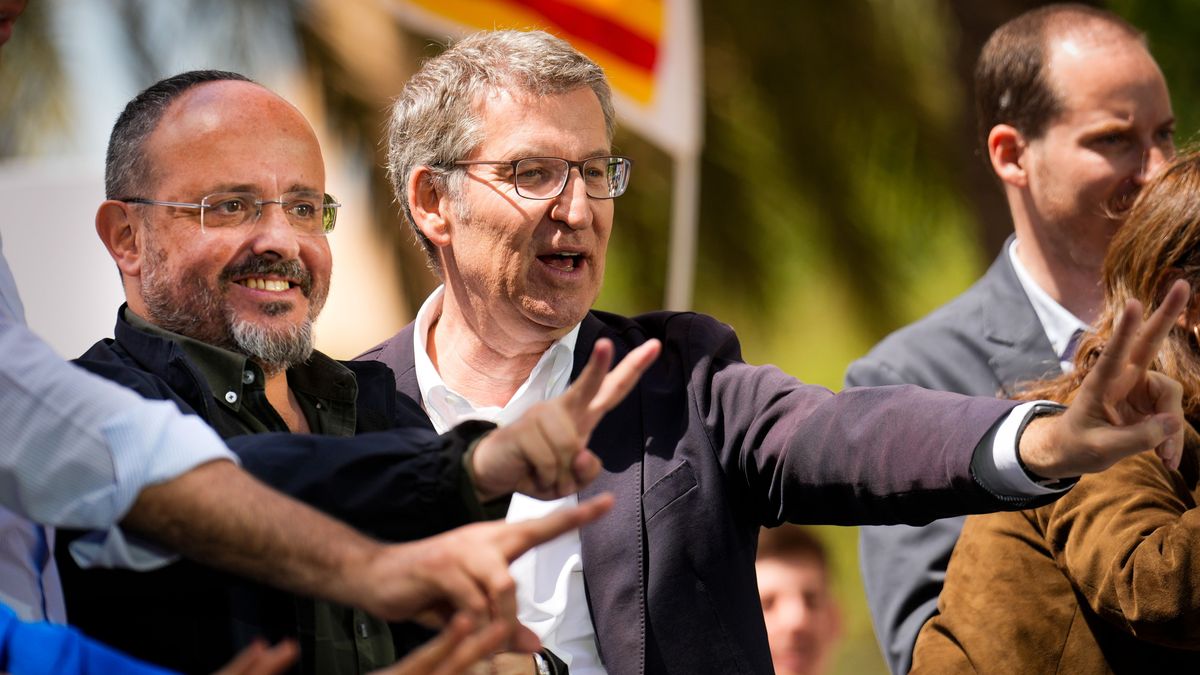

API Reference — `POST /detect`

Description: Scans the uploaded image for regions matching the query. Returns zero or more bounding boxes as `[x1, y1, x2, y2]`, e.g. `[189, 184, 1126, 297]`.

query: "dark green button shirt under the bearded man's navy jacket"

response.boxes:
[125, 309, 396, 675]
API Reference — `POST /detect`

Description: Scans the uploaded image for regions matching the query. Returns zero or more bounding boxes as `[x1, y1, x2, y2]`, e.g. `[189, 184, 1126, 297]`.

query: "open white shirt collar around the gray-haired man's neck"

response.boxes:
[413, 286, 580, 434]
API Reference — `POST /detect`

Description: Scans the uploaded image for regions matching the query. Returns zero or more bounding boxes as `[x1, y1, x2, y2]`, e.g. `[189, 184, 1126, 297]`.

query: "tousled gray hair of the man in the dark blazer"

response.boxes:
[388, 30, 616, 276]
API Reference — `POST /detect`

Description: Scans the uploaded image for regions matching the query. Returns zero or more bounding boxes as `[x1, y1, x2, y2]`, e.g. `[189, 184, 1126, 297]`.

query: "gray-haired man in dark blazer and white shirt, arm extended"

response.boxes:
[365, 23, 1187, 675]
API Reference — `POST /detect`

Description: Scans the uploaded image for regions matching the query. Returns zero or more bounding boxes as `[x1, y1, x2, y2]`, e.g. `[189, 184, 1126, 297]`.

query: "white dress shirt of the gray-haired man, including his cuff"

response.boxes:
[413, 278, 1080, 675]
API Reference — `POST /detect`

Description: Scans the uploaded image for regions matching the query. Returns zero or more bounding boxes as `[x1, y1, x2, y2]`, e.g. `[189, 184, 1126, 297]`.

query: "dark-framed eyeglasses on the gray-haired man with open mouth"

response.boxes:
[455, 155, 634, 199]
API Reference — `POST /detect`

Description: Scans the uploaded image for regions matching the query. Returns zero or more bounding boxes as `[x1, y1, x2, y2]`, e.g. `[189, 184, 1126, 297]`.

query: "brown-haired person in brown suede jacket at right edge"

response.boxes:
[913, 153, 1200, 675]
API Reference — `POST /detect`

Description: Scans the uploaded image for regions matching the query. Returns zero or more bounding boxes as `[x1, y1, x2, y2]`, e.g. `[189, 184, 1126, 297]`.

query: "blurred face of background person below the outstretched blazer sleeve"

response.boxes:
[754, 525, 841, 675]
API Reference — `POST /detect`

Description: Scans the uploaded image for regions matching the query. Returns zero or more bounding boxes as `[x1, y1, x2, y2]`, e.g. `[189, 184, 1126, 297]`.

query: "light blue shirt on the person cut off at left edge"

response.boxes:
[0, 233, 234, 622]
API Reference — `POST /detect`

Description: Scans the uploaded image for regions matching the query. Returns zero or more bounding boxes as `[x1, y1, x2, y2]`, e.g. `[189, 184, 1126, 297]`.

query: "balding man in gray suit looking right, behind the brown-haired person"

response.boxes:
[846, 5, 1174, 673]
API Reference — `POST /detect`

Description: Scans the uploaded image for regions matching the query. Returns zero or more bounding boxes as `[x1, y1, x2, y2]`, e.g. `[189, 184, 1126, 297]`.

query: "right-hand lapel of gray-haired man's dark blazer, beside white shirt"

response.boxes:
[571, 313, 646, 673]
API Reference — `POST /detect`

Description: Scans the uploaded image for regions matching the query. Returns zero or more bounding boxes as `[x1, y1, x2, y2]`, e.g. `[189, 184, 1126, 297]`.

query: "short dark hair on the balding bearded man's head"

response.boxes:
[104, 70, 253, 199]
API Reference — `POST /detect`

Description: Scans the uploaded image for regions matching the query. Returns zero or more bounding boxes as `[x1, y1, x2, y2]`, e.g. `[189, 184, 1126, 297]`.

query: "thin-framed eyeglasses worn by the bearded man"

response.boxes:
[115, 191, 342, 237]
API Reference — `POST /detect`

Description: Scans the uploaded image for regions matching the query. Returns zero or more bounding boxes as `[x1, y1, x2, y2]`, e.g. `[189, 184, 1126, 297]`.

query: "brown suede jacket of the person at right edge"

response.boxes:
[912, 440, 1200, 674]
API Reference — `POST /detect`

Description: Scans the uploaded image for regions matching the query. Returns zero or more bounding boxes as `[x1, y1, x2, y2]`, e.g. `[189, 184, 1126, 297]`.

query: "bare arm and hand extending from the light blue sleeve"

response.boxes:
[124, 462, 612, 651]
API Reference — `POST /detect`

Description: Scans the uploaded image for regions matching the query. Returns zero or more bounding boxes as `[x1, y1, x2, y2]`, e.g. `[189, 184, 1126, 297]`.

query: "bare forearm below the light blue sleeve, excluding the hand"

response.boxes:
[121, 461, 382, 607]
